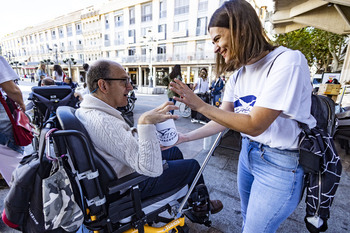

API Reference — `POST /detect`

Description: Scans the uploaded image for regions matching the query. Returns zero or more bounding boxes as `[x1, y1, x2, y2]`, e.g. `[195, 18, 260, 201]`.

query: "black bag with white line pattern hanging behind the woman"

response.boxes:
[299, 95, 342, 233]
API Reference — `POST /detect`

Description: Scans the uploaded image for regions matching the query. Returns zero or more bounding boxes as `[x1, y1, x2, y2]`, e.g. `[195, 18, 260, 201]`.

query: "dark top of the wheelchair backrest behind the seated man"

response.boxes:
[32, 86, 72, 100]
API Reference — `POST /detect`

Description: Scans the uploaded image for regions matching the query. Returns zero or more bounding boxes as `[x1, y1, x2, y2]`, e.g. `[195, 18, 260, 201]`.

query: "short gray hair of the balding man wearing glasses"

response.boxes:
[87, 60, 111, 92]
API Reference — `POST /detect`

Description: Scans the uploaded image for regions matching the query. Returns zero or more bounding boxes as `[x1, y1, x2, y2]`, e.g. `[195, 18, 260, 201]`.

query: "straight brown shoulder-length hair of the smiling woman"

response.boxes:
[208, 0, 275, 75]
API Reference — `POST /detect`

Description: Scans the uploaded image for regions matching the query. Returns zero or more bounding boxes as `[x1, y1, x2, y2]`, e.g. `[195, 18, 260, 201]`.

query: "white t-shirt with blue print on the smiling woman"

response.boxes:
[223, 46, 316, 149]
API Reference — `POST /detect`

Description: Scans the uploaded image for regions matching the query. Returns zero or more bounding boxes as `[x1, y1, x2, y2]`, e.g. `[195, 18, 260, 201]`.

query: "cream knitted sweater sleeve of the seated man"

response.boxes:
[85, 111, 163, 177]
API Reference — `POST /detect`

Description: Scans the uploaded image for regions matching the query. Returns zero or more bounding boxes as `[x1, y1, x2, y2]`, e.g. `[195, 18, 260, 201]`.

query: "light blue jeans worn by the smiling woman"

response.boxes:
[237, 137, 304, 233]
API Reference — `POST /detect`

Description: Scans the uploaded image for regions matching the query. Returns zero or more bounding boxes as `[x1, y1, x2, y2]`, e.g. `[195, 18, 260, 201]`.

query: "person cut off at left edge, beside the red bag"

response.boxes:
[0, 56, 25, 185]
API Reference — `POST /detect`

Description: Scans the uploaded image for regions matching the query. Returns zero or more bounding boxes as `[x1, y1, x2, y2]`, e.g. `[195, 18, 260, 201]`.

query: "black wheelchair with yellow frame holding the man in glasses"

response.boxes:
[47, 106, 211, 233]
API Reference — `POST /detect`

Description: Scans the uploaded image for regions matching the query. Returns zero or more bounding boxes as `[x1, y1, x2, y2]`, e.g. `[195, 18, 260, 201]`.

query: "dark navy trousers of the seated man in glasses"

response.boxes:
[139, 146, 204, 199]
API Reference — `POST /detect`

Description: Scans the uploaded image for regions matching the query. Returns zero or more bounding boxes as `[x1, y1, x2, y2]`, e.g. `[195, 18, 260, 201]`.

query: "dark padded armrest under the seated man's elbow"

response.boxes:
[108, 172, 149, 194]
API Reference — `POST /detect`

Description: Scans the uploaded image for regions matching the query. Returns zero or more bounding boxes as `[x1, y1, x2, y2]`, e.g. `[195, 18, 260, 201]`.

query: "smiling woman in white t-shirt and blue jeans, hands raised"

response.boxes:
[171, 0, 316, 233]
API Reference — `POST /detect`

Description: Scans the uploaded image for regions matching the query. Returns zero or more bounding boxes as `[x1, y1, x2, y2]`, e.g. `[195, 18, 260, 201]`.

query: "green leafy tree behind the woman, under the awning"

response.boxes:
[274, 27, 348, 73]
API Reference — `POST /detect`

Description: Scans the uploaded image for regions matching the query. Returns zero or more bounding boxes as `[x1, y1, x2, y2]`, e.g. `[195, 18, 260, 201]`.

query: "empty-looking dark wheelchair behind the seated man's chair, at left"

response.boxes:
[26, 86, 79, 151]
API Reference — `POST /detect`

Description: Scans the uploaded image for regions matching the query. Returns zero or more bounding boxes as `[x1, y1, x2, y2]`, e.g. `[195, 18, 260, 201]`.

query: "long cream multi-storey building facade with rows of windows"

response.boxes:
[0, 0, 265, 87]
